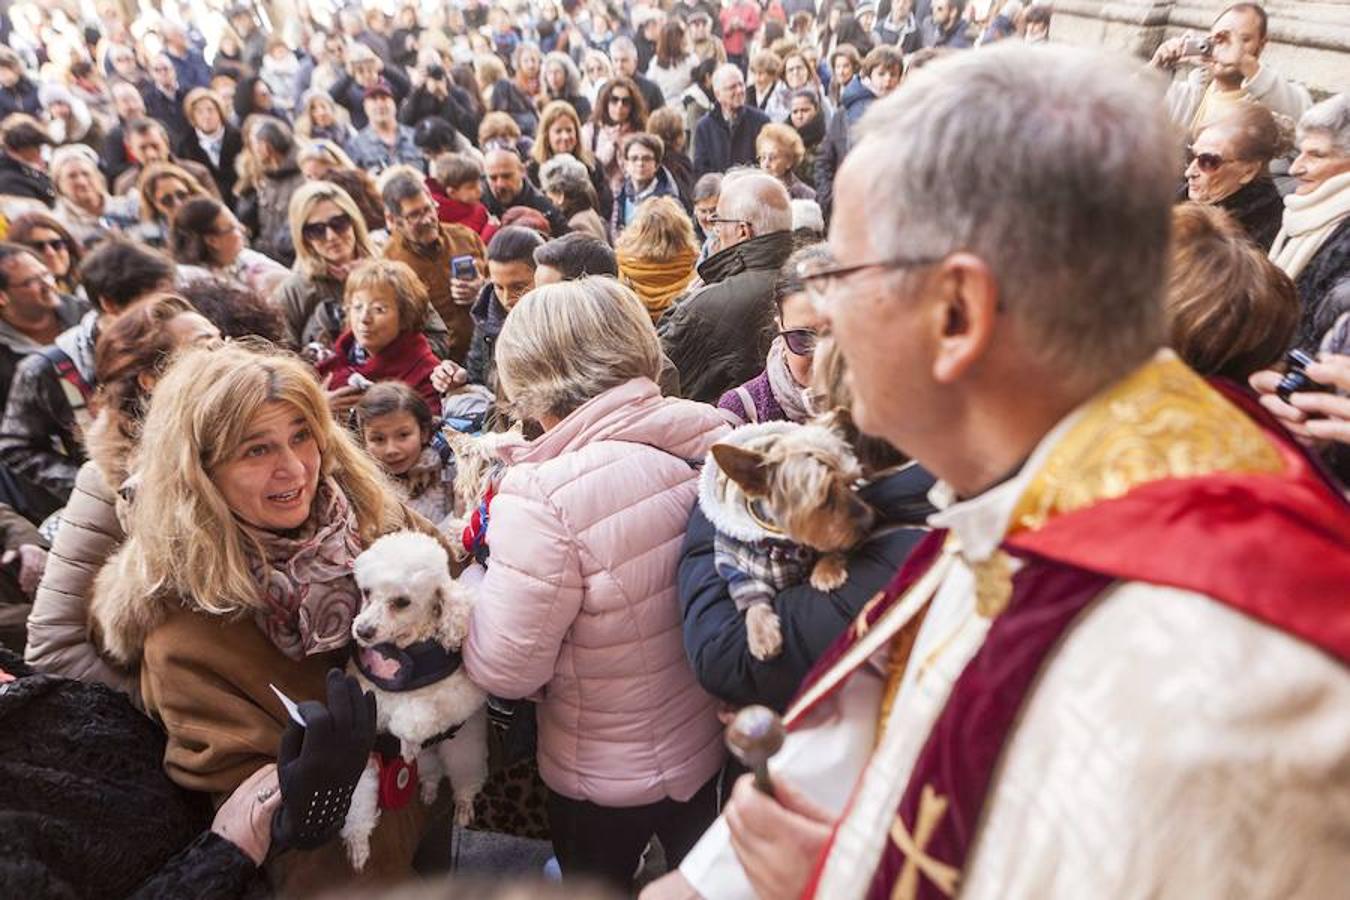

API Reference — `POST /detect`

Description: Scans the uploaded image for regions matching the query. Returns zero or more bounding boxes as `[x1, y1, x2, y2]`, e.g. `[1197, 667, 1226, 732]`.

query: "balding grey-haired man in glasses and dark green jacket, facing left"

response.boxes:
[657, 170, 792, 403]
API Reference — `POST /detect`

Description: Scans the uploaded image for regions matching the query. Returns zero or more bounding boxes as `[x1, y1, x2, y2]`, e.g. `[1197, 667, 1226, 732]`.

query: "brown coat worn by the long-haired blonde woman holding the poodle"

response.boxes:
[92, 507, 450, 897]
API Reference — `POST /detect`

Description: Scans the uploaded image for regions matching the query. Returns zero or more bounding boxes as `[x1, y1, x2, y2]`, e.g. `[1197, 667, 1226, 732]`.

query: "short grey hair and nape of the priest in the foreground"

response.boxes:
[845, 42, 1181, 385]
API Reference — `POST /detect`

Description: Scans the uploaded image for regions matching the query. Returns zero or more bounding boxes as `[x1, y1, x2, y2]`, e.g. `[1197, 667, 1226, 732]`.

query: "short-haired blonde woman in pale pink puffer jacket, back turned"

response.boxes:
[463, 277, 726, 888]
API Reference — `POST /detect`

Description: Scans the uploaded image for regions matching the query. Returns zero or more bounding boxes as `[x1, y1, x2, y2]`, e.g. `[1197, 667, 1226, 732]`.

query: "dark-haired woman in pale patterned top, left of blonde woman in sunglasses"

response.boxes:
[169, 197, 288, 297]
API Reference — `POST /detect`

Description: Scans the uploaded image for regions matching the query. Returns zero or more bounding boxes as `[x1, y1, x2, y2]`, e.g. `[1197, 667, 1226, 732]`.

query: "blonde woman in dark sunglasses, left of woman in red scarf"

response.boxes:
[277, 181, 375, 349]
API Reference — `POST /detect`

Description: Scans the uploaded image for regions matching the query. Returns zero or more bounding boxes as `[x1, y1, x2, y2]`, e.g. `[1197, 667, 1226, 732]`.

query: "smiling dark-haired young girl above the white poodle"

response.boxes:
[356, 382, 455, 532]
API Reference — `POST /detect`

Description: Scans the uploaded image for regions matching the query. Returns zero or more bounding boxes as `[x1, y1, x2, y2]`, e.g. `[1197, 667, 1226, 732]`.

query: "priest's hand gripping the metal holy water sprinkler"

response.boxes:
[724, 775, 834, 900]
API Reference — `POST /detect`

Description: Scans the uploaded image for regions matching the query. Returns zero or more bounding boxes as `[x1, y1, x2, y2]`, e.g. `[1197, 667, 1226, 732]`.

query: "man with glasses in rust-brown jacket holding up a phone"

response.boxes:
[381, 166, 486, 363]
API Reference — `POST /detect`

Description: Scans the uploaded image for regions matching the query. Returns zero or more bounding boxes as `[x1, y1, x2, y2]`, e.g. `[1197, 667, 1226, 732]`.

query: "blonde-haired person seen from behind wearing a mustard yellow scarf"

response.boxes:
[614, 197, 698, 322]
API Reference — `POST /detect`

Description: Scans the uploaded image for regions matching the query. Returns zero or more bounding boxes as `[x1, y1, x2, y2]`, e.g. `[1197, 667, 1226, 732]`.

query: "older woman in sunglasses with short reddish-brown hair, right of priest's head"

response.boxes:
[1185, 101, 1288, 250]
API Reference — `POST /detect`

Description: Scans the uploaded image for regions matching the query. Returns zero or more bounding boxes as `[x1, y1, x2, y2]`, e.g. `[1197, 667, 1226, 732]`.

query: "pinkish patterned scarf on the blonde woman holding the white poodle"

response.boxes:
[244, 478, 360, 660]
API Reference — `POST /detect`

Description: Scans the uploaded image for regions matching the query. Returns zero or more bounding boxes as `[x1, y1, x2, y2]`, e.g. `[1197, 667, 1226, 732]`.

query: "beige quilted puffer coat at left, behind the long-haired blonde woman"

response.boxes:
[24, 461, 140, 704]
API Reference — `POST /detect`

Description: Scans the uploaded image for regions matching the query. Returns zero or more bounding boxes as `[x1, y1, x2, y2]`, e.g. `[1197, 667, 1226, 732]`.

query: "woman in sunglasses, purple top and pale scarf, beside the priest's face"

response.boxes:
[717, 244, 829, 422]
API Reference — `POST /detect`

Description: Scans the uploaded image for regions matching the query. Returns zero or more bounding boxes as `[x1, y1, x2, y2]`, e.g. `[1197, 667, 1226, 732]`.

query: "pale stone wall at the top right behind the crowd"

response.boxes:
[1050, 0, 1350, 97]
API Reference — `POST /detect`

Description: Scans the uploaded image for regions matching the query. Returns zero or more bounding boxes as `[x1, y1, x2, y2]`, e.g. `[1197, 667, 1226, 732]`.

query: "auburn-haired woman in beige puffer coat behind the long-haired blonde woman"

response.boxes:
[24, 294, 220, 706]
